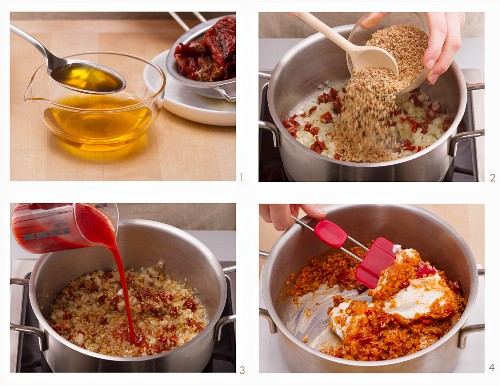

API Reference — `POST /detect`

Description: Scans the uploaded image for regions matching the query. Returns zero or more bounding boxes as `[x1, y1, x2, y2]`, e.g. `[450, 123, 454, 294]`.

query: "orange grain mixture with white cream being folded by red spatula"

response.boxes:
[287, 246, 466, 361]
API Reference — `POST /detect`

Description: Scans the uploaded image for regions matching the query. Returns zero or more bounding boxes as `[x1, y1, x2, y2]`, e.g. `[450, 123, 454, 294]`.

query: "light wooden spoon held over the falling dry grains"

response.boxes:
[298, 12, 399, 76]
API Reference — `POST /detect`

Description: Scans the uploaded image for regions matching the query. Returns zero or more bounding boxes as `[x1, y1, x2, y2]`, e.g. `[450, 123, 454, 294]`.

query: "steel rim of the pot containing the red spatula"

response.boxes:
[261, 204, 479, 367]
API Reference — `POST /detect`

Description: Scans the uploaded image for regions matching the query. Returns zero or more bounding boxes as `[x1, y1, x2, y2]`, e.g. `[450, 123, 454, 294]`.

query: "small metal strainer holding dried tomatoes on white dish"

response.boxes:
[167, 15, 236, 102]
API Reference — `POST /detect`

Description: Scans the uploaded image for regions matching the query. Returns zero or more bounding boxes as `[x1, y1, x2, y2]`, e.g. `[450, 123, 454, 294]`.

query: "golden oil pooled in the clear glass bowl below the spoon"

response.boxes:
[44, 93, 154, 151]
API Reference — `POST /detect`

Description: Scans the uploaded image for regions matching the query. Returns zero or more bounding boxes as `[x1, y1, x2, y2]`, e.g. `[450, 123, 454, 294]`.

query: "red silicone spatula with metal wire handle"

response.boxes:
[292, 216, 395, 288]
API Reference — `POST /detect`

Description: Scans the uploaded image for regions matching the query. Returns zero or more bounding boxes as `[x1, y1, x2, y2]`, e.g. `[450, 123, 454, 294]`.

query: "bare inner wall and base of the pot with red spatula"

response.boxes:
[263, 205, 478, 348]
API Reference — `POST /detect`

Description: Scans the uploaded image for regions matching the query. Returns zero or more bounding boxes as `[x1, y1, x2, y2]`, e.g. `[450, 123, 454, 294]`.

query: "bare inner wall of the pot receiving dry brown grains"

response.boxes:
[268, 26, 465, 133]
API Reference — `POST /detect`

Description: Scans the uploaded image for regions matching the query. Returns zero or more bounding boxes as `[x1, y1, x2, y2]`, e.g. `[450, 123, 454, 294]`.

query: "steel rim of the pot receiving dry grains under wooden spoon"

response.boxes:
[267, 24, 467, 168]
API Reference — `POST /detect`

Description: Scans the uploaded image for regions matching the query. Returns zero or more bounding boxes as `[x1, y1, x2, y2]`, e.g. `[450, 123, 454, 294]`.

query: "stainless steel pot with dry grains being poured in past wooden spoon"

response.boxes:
[259, 25, 484, 181]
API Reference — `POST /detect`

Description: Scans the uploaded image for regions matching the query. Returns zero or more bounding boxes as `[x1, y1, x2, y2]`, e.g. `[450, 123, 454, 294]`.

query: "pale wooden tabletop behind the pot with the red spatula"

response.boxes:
[259, 204, 485, 272]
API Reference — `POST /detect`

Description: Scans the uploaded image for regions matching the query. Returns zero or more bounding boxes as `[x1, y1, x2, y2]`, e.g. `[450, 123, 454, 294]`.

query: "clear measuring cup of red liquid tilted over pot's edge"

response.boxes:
[12, 204, 118, 253]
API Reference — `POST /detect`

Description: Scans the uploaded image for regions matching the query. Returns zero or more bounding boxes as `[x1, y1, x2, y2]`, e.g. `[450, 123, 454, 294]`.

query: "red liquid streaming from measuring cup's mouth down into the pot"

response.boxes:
[75, 204, 136, 344]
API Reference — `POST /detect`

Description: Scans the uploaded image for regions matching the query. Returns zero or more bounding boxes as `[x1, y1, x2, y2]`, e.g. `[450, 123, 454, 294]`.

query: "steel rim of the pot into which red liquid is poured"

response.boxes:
[29, 219, 227, 362]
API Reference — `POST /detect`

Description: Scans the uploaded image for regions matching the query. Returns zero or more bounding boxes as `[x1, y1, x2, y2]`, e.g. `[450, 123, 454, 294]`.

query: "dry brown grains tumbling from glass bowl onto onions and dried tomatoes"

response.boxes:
[283, 26, 451, 162]
